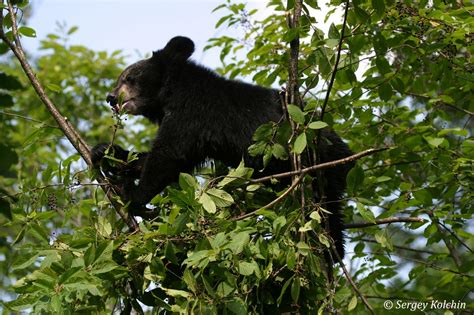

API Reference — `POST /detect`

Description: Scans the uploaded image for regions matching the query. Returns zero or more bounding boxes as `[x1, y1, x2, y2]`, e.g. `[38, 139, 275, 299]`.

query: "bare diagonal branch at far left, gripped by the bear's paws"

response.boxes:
[0, 0, 138, 230]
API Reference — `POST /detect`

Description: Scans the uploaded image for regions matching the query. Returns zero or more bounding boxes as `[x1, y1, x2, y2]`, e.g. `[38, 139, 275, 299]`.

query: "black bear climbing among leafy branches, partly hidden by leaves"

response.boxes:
[92, 37, 352, 257]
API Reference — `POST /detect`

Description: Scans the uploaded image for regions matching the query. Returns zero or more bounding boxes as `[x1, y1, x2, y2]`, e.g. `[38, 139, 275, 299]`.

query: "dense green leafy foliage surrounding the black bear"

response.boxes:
[0, 0, 474, 314]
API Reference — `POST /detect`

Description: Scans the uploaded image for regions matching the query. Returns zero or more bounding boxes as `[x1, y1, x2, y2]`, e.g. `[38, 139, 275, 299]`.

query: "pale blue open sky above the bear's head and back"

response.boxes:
[23, 0, 267, 68]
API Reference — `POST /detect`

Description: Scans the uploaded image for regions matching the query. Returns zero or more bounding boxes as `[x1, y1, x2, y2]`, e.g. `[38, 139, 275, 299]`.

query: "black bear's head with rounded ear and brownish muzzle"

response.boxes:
[107, 36, 194, 118]
